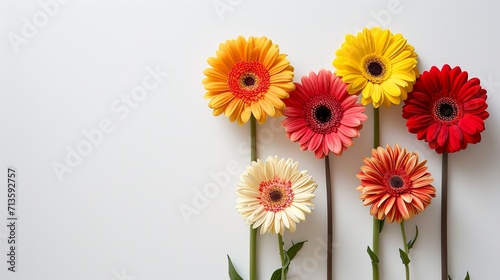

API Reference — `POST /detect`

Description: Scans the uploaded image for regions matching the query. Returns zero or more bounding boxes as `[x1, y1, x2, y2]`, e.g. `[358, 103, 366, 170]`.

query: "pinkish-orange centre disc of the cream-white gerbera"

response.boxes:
[259, 178, 294, 212]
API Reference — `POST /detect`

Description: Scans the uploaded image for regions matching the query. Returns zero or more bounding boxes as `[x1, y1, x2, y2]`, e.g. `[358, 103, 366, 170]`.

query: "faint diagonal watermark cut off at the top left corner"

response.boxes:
[7, 0, 70, 53]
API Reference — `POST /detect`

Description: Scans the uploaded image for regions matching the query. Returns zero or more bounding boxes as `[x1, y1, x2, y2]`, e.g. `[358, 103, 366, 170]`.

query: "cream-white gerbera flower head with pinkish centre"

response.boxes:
[236, 156, 317, 235]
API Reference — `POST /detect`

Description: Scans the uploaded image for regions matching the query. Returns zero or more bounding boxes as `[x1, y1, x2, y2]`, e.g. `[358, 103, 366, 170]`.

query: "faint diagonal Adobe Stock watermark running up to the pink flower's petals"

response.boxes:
[178, 118, 284, 224]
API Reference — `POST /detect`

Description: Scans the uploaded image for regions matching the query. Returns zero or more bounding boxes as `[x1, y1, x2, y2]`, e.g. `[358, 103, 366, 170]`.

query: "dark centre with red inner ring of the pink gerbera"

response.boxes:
[304, 94, 344, 134]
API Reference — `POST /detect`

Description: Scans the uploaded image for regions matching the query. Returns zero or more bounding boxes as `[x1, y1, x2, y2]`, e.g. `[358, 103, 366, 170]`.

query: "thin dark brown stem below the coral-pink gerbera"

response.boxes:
[325, 155, 333, 280]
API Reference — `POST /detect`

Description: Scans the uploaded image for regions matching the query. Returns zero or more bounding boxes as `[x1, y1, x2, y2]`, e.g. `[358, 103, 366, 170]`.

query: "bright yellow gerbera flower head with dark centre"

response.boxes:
[333, 27, 418, 108]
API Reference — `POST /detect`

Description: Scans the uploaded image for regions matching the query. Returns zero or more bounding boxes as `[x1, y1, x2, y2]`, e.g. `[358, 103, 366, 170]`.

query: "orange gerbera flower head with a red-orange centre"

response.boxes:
[203, 36, 295, 124]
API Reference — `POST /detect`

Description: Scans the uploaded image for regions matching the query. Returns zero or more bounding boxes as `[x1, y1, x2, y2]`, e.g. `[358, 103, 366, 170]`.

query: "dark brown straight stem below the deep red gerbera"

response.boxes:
[441, 152, 448, 280]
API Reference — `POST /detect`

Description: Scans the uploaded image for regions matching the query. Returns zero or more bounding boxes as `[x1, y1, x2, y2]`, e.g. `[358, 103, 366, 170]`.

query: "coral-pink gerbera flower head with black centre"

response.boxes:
[282, 70, 367, 158]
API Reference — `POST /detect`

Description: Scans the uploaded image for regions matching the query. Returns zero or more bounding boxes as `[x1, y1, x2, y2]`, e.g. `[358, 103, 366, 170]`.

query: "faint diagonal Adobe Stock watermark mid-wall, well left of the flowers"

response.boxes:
[51, 65, 169, 182]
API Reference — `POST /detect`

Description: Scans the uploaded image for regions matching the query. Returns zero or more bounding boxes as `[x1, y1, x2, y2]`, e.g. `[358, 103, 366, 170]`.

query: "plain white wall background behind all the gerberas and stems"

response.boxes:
[0, 0, 500, 280]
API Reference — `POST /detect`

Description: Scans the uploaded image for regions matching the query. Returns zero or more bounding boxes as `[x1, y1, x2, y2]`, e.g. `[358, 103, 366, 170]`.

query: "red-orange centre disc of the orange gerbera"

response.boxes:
[228, 61, 271, 104]
